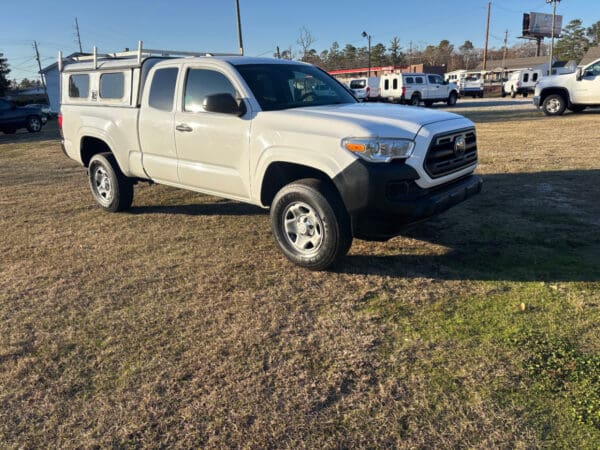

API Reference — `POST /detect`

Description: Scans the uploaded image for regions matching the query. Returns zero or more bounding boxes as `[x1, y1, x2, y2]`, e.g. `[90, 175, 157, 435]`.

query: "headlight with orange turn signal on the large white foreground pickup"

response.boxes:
[342, 138, 415, 162]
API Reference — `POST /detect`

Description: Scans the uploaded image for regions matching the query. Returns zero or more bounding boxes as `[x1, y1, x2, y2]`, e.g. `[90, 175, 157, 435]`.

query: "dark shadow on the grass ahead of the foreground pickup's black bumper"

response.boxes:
[335, 170, 600, 281]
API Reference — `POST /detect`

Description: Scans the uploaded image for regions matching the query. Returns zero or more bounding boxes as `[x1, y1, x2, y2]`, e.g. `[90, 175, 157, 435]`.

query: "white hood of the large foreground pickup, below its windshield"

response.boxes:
[259, 103, 467, 139]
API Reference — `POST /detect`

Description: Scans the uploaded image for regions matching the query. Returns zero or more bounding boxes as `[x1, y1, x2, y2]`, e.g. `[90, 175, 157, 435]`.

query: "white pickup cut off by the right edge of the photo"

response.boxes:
[533, 59, 600, 116]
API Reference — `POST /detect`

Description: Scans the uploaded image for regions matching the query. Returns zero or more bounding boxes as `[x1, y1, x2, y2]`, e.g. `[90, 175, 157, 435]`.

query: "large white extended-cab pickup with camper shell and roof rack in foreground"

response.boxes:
[59, 45, 482, 270]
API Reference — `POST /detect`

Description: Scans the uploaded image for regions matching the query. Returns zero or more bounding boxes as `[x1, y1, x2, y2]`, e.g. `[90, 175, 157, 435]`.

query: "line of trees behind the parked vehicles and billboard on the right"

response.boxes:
[286, 19, 600, 71]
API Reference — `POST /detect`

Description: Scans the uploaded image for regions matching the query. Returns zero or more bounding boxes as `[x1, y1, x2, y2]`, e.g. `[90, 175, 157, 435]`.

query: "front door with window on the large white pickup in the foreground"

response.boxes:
[175, 63, 251, 199]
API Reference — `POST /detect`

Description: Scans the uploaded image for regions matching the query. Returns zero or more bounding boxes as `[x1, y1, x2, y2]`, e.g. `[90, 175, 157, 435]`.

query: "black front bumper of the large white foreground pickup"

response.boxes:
[333, 160, 483, 240]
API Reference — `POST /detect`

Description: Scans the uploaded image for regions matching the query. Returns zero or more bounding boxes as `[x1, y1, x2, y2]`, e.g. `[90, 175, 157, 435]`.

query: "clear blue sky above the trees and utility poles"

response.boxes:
[0, 0, 600, 79]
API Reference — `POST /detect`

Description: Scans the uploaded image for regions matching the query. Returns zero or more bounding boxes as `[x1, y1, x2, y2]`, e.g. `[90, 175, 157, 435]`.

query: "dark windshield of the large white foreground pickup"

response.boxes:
[236, 64, 356, 111]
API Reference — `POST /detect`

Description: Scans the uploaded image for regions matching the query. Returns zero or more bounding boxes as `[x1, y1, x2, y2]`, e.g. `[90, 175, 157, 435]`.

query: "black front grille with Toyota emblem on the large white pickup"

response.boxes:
[425, 128, 477, 178]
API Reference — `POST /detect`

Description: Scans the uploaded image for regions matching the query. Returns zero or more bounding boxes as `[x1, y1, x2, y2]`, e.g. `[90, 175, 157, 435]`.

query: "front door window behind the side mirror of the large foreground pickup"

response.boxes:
[183, 69, 237, 112]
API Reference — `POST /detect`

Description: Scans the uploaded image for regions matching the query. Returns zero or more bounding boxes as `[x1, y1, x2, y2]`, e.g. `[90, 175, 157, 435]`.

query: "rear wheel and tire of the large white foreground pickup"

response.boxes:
[88, 153, 133, 212]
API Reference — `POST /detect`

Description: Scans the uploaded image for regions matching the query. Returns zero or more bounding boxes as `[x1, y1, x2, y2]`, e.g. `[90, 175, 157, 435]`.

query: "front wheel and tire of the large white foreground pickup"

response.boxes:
[271, 178, 352, 270]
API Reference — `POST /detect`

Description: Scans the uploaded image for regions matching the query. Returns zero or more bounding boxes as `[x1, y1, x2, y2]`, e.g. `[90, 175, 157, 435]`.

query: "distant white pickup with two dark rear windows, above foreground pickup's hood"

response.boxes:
[381, 73, 458, 106]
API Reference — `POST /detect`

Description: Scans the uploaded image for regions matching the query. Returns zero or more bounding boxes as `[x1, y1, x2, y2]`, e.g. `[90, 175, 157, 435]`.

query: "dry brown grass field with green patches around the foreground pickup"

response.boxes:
[0, 100, 600, 449]
